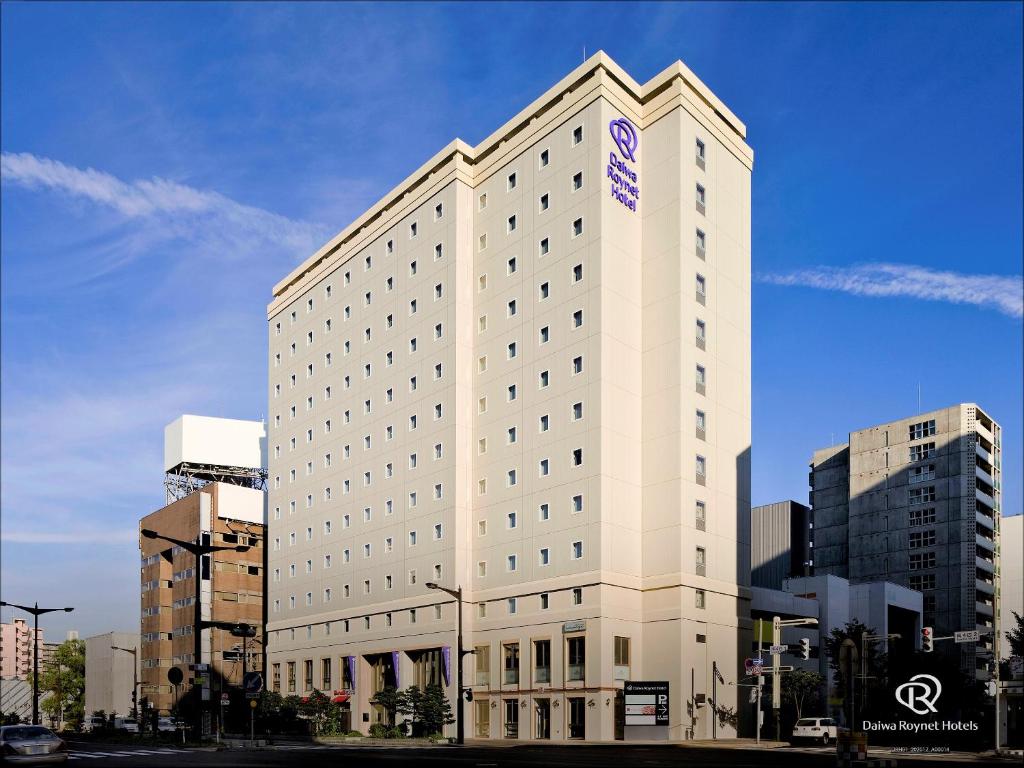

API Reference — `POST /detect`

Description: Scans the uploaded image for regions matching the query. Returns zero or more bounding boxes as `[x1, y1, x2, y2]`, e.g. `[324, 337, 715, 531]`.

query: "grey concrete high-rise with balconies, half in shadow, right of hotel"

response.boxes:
[810, 403, 1002, 679]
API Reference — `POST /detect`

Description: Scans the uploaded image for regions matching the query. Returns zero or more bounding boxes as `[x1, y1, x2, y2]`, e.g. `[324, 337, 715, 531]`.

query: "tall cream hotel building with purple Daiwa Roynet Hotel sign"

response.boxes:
[267, 53, 753, 740]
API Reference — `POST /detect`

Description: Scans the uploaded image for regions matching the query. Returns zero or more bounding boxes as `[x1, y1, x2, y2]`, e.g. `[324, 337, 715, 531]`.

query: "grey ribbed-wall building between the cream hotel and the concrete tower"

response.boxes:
[751, 501, 814, 590]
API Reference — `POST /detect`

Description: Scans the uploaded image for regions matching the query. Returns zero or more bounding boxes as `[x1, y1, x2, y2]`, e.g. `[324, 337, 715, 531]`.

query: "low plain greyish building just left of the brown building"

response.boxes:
[85, 632, 141, 717]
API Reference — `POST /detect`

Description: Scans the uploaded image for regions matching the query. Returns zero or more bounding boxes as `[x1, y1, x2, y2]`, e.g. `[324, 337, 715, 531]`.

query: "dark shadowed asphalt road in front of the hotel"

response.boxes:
[69, 741, 1019, 768]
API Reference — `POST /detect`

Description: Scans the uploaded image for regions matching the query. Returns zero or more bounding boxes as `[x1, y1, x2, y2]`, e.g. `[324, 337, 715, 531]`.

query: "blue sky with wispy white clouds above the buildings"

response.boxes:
[0, 3, 1024, 635]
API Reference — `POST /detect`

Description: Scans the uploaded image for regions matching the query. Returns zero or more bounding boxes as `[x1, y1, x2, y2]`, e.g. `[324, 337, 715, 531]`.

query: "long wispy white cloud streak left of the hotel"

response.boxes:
[0, 152, 328, 256]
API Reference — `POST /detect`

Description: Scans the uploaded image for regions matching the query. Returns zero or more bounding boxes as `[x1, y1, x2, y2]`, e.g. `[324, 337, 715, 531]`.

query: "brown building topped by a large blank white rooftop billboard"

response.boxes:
[136, 416, 266, 714]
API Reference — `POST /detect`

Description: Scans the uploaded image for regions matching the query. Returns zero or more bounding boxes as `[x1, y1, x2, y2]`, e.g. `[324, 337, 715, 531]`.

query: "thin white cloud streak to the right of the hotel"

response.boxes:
[757, 263, 1024, 318]
